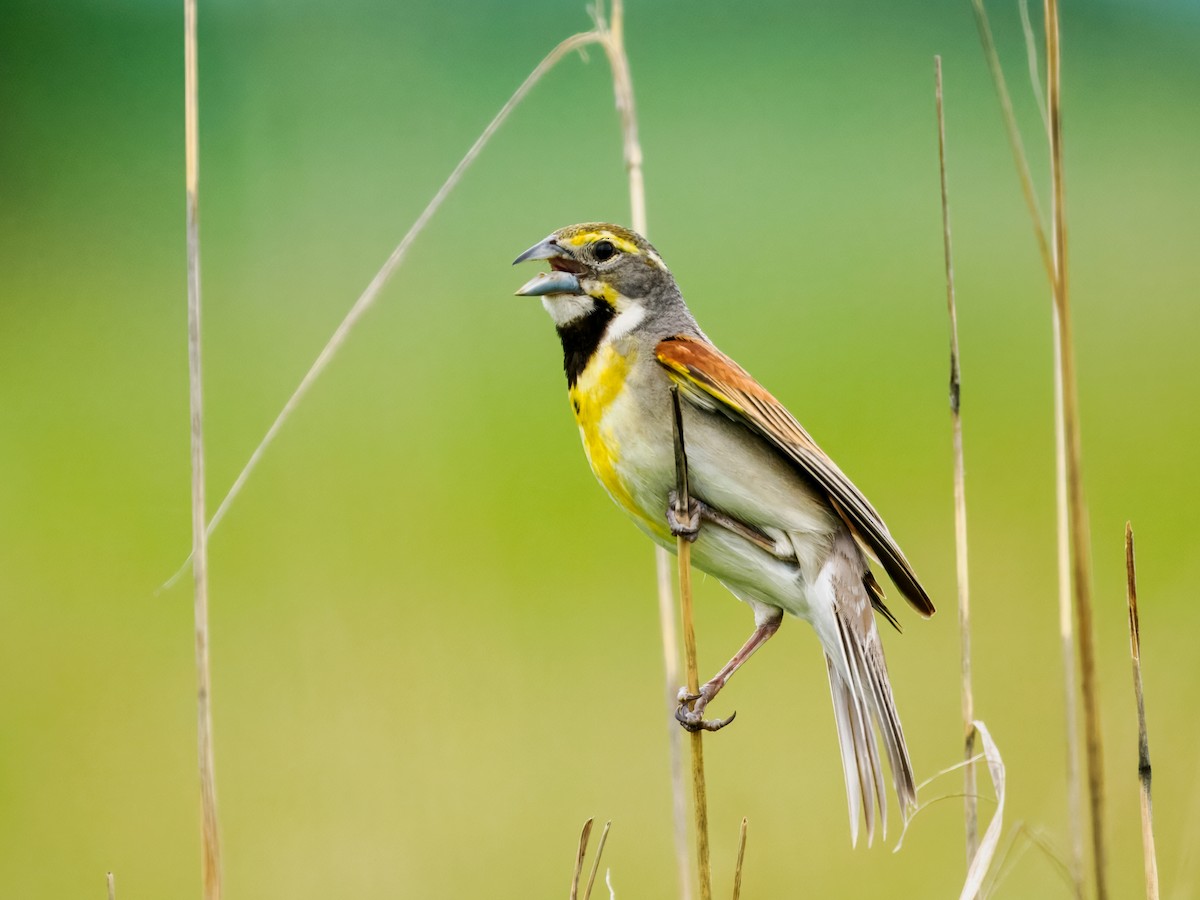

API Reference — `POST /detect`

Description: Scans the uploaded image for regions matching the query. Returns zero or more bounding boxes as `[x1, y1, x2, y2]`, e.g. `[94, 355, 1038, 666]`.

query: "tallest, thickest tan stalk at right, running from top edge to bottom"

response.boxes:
[1045, 0, 1109, 900]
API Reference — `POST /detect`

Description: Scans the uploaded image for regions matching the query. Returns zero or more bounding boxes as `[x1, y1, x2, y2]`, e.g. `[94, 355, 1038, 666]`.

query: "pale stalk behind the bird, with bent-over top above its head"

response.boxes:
[595, 0, 694, 900]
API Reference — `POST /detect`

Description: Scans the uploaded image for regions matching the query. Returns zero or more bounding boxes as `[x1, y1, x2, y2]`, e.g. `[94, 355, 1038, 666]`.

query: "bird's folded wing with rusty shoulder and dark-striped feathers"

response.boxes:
[655, 335, 934, 617]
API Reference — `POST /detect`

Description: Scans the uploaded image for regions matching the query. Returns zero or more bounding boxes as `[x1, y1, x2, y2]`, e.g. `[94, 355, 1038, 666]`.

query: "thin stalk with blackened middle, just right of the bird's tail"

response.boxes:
[934, 56, 979, 866]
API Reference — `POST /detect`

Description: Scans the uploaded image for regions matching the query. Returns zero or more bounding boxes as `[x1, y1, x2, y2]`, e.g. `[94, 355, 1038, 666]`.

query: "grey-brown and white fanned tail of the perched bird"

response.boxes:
[824, 554, 917, 845]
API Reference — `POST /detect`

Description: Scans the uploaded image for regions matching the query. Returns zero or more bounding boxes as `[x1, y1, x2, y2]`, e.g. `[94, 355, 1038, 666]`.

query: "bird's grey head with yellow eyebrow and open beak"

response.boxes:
[514, 223, 678, 326]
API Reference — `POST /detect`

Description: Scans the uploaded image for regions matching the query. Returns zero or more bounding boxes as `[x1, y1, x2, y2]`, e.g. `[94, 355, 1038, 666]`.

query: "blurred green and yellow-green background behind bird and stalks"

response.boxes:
[0, 0, 1200, 900]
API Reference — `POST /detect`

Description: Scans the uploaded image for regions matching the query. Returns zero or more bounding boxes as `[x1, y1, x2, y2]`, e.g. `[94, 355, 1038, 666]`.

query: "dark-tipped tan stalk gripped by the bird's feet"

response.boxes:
[671, 384, 713, 900]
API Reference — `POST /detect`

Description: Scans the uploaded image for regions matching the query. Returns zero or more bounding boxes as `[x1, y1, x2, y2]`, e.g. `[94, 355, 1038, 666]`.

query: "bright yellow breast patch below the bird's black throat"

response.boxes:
[569, 344, 637, 515]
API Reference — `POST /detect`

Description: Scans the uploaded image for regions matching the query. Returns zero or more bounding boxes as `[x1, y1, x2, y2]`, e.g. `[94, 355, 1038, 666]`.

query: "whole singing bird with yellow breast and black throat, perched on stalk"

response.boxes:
[515, 223, 934, 842]
